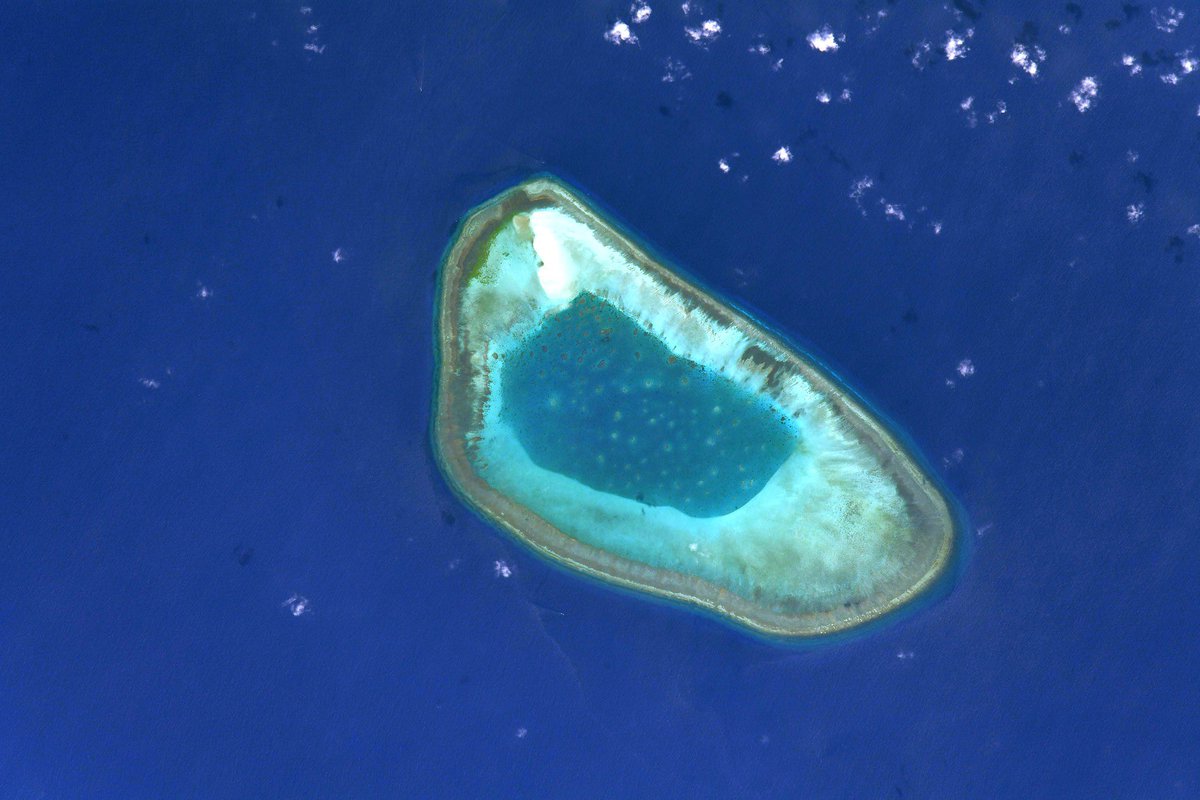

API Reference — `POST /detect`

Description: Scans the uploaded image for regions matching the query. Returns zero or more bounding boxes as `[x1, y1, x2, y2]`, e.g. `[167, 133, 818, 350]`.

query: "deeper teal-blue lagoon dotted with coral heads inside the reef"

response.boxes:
[500, 294, 798, 517]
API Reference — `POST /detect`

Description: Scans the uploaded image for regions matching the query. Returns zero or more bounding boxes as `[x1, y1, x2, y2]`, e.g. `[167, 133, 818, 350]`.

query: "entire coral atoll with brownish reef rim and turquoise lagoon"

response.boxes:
[433, 176, 955, 637]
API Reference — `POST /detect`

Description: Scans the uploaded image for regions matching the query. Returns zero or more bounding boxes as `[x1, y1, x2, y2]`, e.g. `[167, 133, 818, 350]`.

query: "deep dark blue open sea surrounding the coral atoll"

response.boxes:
[0, 0, 1200, 799]
